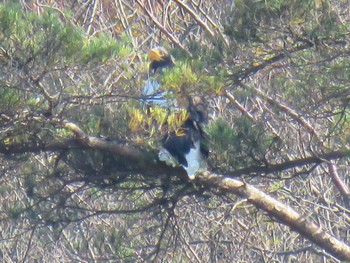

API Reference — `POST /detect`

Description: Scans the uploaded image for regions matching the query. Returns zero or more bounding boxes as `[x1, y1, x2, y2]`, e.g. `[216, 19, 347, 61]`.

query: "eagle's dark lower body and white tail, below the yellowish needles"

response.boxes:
[159, 96, 209, 180]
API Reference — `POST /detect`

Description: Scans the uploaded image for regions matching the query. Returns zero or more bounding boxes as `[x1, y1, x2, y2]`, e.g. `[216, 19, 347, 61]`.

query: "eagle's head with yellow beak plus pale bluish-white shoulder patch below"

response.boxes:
[143, 46, 175, 106]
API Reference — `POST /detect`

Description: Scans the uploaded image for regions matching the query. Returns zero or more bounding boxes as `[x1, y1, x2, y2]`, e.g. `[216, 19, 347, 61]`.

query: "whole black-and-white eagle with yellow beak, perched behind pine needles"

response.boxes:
[144, 46, 208, 180]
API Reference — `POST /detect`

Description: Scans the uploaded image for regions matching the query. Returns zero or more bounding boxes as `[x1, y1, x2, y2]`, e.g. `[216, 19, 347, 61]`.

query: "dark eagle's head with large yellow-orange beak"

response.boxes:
[148, 46, 175, 73]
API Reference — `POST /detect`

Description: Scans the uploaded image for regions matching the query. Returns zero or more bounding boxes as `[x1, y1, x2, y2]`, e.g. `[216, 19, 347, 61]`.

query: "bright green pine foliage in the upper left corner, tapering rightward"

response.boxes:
[0, 3, 126, 66]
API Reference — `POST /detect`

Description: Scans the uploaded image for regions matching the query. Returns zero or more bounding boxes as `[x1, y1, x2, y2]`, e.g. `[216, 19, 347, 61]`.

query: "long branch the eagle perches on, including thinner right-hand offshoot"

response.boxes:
[0, 131, 350, 260]
